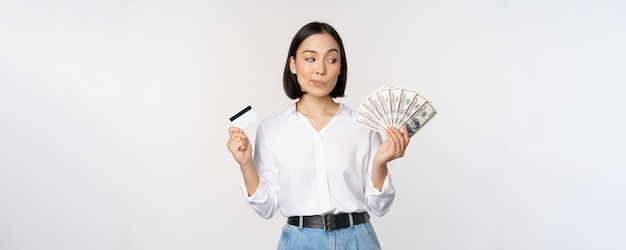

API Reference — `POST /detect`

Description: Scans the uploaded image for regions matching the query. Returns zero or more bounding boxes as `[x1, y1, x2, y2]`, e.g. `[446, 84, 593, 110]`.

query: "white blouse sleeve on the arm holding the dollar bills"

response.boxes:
[365, 132, 396, 216]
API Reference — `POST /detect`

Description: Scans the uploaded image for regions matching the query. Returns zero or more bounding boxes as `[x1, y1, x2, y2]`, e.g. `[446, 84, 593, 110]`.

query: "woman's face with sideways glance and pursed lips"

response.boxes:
[289, 34, 341, 97]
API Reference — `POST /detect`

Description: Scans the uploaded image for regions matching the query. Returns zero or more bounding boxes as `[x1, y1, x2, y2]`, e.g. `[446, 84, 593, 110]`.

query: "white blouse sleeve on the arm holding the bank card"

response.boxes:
[241, 123, 279, 219]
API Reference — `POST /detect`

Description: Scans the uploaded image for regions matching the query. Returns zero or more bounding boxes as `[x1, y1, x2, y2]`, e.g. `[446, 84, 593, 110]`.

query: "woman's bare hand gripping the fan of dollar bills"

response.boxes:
[374, 126, 410, 165]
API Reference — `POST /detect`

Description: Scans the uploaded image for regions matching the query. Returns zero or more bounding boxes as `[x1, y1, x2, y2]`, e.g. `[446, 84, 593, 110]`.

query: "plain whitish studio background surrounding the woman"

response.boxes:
[0, 0, 626, 250]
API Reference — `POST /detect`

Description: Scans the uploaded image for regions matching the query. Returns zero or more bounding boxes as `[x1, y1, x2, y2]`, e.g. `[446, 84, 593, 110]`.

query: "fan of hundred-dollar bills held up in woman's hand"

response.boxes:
[356, 86, 437, 136]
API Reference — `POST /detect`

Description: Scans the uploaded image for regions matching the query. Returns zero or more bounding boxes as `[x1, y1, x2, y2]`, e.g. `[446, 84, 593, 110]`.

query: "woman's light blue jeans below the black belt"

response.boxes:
[278, 221, 380, 250]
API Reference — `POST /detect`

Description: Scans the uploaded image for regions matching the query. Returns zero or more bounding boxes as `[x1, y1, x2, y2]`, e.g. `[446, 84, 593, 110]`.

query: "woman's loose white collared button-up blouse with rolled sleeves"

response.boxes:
[241, 103, 395, 219]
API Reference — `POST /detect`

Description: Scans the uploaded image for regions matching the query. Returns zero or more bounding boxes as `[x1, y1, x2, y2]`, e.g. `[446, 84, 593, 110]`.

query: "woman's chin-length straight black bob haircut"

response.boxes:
[283, 22, 348, 99]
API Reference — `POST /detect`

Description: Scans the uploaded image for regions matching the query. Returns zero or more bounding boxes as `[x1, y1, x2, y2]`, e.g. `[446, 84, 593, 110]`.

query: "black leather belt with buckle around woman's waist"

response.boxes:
[287, 212, 370, 231]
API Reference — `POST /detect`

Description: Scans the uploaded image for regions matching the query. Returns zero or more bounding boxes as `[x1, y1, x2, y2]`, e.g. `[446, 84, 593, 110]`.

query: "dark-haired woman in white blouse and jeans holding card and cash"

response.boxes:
[227, 22, 409, 249]
